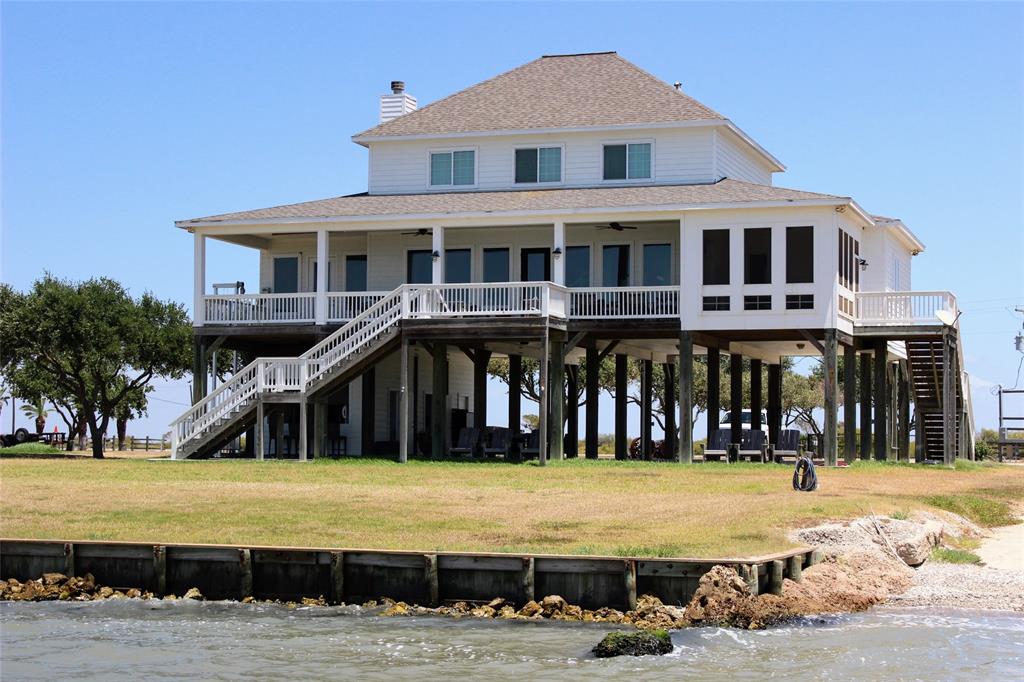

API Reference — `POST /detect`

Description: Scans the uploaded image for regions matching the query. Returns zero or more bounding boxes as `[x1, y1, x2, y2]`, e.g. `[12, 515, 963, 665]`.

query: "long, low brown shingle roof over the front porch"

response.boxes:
[176, 178, 849, 227]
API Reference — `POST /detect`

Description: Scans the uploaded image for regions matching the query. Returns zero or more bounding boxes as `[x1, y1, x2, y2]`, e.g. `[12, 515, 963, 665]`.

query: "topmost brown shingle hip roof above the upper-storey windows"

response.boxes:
[355, 52, 724, 138]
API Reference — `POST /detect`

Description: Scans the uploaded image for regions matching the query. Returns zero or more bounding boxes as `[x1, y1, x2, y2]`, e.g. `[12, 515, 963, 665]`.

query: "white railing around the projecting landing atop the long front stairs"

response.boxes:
[408, 282, 565, 317]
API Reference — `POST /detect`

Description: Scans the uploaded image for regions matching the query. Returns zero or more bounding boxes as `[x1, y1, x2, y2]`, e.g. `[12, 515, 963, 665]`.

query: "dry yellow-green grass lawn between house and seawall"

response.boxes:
[0, 450, 1024, 557]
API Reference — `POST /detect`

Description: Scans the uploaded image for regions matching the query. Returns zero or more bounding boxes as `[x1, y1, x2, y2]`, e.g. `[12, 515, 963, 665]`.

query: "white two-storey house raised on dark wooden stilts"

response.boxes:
[172, 52, 973, 463]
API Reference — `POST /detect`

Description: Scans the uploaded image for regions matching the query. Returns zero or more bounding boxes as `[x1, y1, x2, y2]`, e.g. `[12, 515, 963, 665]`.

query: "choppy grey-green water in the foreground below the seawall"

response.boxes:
[0, 600, 1024, 681]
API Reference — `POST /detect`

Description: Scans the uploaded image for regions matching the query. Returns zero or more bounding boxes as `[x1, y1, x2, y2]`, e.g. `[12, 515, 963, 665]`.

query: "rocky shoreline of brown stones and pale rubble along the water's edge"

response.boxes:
[0, 513, 1024, 631]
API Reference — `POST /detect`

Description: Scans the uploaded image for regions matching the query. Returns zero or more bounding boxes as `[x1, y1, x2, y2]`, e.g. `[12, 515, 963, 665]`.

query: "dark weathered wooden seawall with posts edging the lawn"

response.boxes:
[0, 539, 819, 610]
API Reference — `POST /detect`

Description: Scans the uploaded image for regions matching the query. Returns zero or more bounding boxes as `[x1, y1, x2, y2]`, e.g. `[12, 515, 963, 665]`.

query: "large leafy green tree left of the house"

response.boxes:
[0, 274, 193, 458]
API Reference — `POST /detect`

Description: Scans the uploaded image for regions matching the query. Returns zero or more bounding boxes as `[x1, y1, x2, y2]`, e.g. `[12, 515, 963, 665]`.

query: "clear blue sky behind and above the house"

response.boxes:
[0, 2, 1024, 436]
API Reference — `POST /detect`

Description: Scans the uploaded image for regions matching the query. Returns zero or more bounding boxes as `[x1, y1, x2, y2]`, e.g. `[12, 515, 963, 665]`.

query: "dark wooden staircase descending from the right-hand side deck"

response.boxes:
[904, 335, 970, 463]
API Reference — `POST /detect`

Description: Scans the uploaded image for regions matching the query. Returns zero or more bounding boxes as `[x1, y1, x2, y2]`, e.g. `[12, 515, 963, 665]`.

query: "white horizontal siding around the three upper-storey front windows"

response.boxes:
[370, 127, 715, 194]
